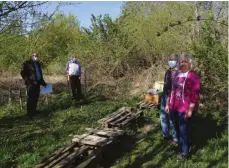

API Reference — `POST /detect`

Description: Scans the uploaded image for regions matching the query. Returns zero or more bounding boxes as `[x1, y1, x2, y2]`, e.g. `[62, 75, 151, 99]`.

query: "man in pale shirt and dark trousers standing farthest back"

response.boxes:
[66, 55, 82, 101]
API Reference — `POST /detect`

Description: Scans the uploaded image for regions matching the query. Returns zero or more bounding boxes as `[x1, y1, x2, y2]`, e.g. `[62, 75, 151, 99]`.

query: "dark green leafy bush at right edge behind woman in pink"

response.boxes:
[190, 15, 228, 110]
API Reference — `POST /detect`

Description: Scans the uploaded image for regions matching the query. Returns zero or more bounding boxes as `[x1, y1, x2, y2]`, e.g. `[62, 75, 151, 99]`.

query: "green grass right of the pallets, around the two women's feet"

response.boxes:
[112, 110, 228, 168]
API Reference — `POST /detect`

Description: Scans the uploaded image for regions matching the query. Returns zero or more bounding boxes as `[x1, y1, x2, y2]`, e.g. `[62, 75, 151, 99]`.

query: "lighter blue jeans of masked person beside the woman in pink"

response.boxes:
[160, 96, 178, 141]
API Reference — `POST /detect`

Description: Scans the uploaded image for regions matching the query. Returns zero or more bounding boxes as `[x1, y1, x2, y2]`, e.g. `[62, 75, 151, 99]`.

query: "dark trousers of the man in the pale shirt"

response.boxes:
[70, 76, 82, 100]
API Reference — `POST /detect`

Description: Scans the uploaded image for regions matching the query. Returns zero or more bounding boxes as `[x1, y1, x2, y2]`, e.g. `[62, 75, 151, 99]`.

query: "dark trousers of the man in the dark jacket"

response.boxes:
[26, 84, 40, 117]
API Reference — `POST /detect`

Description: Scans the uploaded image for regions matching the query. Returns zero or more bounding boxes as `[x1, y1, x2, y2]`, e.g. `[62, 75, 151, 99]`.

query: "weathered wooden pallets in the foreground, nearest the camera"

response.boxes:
[36, 128, 124, 168]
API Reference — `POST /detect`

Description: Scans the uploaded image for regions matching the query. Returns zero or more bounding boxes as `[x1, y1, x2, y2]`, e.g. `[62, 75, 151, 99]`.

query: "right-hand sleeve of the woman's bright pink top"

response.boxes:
[191, 73, 200, 104]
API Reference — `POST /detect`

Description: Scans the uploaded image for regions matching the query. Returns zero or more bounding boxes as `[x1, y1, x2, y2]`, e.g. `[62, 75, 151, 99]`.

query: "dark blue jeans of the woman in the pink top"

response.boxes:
[171, 111, 190, 155]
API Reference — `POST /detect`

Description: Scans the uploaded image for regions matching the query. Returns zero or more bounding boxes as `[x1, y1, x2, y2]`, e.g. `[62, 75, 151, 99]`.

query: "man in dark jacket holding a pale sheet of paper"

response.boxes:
[21, 53, 46, 119]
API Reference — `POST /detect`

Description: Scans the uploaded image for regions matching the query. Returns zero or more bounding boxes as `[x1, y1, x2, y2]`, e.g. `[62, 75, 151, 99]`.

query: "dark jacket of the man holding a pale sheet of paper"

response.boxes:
[21, 59, 46, 86]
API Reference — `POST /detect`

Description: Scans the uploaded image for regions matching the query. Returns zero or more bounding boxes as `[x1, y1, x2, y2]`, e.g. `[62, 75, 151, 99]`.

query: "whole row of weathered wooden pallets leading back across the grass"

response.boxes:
[36, 107, 143, 168]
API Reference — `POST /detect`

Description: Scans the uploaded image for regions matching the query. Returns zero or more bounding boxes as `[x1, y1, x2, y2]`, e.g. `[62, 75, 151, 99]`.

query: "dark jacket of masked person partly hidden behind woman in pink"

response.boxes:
[163, 69, 178, 97]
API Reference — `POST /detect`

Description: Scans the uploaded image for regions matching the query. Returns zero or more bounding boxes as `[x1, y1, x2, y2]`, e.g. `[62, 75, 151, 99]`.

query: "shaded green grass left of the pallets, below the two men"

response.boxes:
[0, 93, 139, 168]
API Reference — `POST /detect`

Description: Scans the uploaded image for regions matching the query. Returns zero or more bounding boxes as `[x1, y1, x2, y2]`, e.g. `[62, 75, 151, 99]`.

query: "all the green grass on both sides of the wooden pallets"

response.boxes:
[0, 93, 228, 168]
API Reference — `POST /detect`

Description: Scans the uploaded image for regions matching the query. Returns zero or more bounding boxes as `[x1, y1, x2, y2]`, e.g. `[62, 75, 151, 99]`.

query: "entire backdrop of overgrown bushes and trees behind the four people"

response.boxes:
[0, 2, 228, 109]
